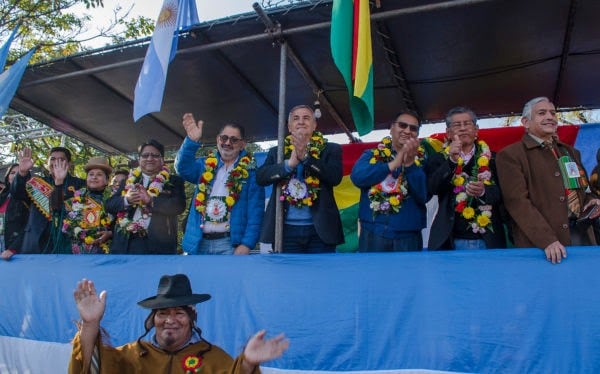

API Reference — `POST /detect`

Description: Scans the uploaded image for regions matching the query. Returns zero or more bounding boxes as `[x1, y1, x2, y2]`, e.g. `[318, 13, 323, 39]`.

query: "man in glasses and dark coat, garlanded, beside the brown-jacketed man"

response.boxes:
[427, 107, 506, 250]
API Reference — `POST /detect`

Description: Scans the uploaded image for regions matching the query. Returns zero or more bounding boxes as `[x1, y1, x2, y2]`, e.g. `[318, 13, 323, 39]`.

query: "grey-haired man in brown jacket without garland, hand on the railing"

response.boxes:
[496, 97, 600, 263]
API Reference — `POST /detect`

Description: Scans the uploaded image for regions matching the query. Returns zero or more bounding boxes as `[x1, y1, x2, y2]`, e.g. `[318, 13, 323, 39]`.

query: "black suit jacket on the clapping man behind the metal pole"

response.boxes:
[256, 143, 344, 245]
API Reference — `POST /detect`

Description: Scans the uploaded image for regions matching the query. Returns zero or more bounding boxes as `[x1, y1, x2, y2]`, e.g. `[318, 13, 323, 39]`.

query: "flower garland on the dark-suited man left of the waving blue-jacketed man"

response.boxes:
[117, 166, 171, 236]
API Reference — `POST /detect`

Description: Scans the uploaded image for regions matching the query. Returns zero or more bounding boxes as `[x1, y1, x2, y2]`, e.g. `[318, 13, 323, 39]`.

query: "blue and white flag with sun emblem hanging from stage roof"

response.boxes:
[133, 0, 199, 122]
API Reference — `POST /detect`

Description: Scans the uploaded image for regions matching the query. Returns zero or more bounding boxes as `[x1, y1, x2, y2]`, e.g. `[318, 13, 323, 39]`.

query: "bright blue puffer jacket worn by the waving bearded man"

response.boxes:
[175, 137, 265, 254]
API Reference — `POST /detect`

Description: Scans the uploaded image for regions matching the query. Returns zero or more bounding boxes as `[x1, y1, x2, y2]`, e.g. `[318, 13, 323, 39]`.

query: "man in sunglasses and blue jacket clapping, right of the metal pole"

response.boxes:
[350, 111, 428, 252]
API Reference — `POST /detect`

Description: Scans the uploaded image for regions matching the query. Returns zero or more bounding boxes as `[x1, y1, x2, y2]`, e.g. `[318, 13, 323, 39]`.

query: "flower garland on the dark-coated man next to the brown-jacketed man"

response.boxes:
[444, 140, 494, 234]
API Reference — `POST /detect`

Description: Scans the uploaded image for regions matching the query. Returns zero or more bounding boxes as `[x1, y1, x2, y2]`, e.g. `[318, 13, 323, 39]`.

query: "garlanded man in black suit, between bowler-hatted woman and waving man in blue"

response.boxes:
[106, 140, 185, 254]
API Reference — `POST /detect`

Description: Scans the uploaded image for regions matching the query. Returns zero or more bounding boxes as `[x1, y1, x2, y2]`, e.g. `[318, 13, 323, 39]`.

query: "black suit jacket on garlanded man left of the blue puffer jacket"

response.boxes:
[106, 175, 185, 254]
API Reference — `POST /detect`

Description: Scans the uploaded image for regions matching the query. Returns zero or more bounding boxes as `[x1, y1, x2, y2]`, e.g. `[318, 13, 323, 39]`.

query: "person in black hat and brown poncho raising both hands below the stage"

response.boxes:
[69, 274, 289, 374]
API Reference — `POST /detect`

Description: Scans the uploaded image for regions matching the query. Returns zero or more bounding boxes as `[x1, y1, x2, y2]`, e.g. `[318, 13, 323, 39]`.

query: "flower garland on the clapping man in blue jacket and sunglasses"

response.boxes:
[369, 136, 425, 215]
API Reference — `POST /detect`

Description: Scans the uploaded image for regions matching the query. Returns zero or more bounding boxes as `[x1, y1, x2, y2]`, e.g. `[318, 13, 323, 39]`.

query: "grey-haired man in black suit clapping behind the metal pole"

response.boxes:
[256, 105, 344, 253]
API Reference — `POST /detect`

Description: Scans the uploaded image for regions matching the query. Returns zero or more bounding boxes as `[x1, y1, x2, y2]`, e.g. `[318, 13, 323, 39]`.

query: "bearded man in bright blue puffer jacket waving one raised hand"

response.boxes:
[175, 113, 265, 255]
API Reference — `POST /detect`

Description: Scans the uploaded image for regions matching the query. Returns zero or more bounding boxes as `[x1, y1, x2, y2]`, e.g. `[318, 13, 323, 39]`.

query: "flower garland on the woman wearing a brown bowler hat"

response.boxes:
[62, 188, 113, 254]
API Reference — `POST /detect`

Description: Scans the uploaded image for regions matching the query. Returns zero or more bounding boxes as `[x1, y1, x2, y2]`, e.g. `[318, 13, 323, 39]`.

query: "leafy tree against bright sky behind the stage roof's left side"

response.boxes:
[0, 0, 154, 166]
